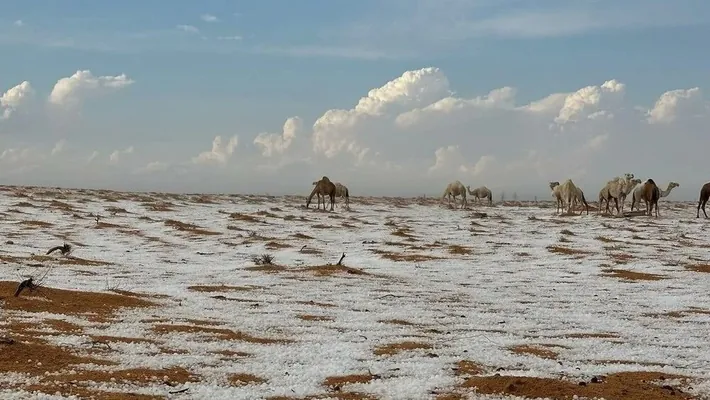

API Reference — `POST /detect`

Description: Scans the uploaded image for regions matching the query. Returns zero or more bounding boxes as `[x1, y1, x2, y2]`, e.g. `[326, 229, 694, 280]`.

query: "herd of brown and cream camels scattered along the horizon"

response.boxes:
[306, 173, 710, 218]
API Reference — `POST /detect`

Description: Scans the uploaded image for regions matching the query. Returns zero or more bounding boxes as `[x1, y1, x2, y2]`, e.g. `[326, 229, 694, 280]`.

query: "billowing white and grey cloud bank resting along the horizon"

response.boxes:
[0, 67, 710, 202]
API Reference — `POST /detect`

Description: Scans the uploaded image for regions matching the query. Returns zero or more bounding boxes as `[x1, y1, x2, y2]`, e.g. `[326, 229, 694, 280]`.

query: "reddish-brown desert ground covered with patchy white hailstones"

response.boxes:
[0, 187, 710, 400]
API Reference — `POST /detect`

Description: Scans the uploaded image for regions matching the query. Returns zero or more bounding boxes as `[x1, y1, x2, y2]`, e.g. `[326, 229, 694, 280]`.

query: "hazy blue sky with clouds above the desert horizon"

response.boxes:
[0, 0, 710, 198]
